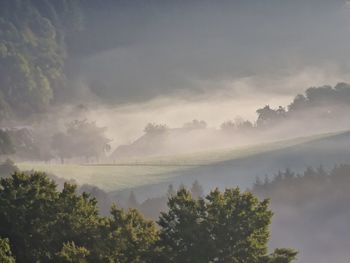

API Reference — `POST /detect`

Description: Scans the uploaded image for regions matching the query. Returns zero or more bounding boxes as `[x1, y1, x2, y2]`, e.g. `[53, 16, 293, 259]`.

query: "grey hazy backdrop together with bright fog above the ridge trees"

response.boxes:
[71, 0, 350, 144]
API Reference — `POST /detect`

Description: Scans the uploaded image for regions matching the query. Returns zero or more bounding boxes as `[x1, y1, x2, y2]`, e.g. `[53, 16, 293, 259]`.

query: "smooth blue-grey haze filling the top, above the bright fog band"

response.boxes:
[71, 0, 350, 103]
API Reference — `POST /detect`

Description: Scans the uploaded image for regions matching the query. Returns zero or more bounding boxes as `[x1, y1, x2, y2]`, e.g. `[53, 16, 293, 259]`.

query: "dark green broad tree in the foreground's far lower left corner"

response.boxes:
[0, 172, 100, 262]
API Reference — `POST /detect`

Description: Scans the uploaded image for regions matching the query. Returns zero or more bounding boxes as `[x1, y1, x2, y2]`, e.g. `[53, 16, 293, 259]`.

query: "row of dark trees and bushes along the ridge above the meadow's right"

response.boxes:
[144, 83, 350, 134]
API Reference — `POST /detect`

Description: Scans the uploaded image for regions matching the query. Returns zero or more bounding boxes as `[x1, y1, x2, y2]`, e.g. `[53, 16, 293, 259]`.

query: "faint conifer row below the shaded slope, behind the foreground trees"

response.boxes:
[119, 164, 350, 225]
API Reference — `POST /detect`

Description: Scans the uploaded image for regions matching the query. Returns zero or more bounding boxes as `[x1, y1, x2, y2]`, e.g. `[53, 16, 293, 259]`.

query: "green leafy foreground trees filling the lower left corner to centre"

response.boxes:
[0, 172, 158, 262]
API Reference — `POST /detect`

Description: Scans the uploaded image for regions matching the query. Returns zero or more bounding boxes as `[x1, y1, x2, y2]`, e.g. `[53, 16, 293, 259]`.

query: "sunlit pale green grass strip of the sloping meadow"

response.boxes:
[17, 134, 331, 191]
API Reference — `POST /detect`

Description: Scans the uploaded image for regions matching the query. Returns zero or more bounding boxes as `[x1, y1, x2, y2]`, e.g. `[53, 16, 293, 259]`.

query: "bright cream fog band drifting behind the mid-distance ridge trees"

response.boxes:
[87, 69, 350, 146]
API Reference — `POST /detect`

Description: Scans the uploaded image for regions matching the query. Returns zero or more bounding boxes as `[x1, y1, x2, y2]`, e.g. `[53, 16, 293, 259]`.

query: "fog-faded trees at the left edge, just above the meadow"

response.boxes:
[0, 119, 111, 163]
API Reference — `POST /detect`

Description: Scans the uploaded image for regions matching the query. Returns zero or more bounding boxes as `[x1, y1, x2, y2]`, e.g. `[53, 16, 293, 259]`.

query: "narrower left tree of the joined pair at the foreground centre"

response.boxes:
[158, 188, 210, 263]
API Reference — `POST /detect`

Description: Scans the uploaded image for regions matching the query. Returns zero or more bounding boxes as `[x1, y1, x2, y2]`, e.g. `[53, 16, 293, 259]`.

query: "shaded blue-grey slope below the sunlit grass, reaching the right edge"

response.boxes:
[125, 132, 350, 200]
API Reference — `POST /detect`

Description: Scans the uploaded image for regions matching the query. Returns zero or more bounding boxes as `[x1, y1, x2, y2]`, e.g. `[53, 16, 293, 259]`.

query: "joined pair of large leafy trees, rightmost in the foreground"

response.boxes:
[158, 188, 295, 263]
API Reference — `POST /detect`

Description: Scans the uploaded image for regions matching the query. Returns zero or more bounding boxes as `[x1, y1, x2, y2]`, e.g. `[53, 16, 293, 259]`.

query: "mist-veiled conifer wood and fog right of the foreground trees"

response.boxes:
[252, 165, 350, 263]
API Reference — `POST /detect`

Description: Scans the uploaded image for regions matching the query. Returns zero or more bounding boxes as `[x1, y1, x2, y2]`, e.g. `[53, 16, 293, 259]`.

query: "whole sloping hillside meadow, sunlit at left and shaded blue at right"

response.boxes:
[18, 132, 350, 199]
